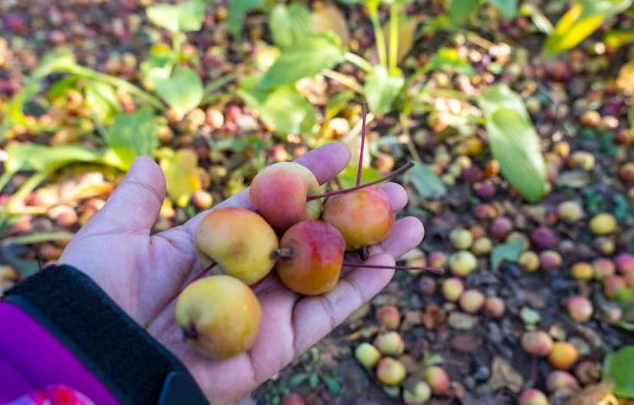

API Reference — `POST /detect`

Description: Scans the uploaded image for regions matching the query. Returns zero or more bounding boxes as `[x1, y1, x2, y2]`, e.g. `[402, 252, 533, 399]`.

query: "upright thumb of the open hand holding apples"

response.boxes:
[90, 156, 165, 232]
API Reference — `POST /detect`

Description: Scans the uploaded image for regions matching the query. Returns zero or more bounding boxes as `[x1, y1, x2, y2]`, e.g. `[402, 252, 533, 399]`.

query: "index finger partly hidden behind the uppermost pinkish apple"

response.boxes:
[185, 143, 350, 234]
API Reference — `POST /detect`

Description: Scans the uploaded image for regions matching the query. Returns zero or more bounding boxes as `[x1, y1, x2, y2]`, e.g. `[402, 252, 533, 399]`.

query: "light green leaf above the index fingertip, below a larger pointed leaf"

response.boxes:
[238, 75, 317, 135]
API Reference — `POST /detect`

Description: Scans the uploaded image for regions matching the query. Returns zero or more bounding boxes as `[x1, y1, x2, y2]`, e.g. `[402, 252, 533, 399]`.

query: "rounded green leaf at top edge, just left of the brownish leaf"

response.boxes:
[269, 3, 312, 49]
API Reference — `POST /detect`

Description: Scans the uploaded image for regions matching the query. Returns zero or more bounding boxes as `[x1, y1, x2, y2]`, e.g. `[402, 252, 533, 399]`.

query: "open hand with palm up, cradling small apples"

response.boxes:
[59, 144, 424, 405]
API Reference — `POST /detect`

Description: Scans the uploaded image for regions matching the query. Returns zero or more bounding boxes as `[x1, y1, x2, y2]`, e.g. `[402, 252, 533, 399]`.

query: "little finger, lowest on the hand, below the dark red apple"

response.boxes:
[293, 254, 394, 354]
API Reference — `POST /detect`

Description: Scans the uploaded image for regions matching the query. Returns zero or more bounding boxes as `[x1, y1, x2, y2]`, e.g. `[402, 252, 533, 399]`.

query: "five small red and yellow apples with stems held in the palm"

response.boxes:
[176, 112, 436, 359]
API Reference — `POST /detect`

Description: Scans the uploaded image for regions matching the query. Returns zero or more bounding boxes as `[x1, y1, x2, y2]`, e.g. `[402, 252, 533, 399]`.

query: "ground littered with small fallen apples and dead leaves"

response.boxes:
[0, 0, 634, 405]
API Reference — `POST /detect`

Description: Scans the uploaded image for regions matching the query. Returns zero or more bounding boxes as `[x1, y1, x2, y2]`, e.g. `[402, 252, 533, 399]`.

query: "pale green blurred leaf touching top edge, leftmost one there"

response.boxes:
[145, 0, 205, 32]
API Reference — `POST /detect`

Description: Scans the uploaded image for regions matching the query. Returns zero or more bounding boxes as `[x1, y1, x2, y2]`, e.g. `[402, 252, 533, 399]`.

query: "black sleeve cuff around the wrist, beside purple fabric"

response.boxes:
[6, 266, 208, 405]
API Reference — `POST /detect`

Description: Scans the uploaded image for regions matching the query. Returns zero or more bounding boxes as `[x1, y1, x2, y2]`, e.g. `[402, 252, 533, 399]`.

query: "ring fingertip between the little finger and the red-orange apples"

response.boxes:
[369, 217, 425, 259]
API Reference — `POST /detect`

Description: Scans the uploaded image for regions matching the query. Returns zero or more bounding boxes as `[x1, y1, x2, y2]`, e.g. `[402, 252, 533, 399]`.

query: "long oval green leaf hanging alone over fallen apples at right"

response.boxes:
[478, 85, 546, 202]
